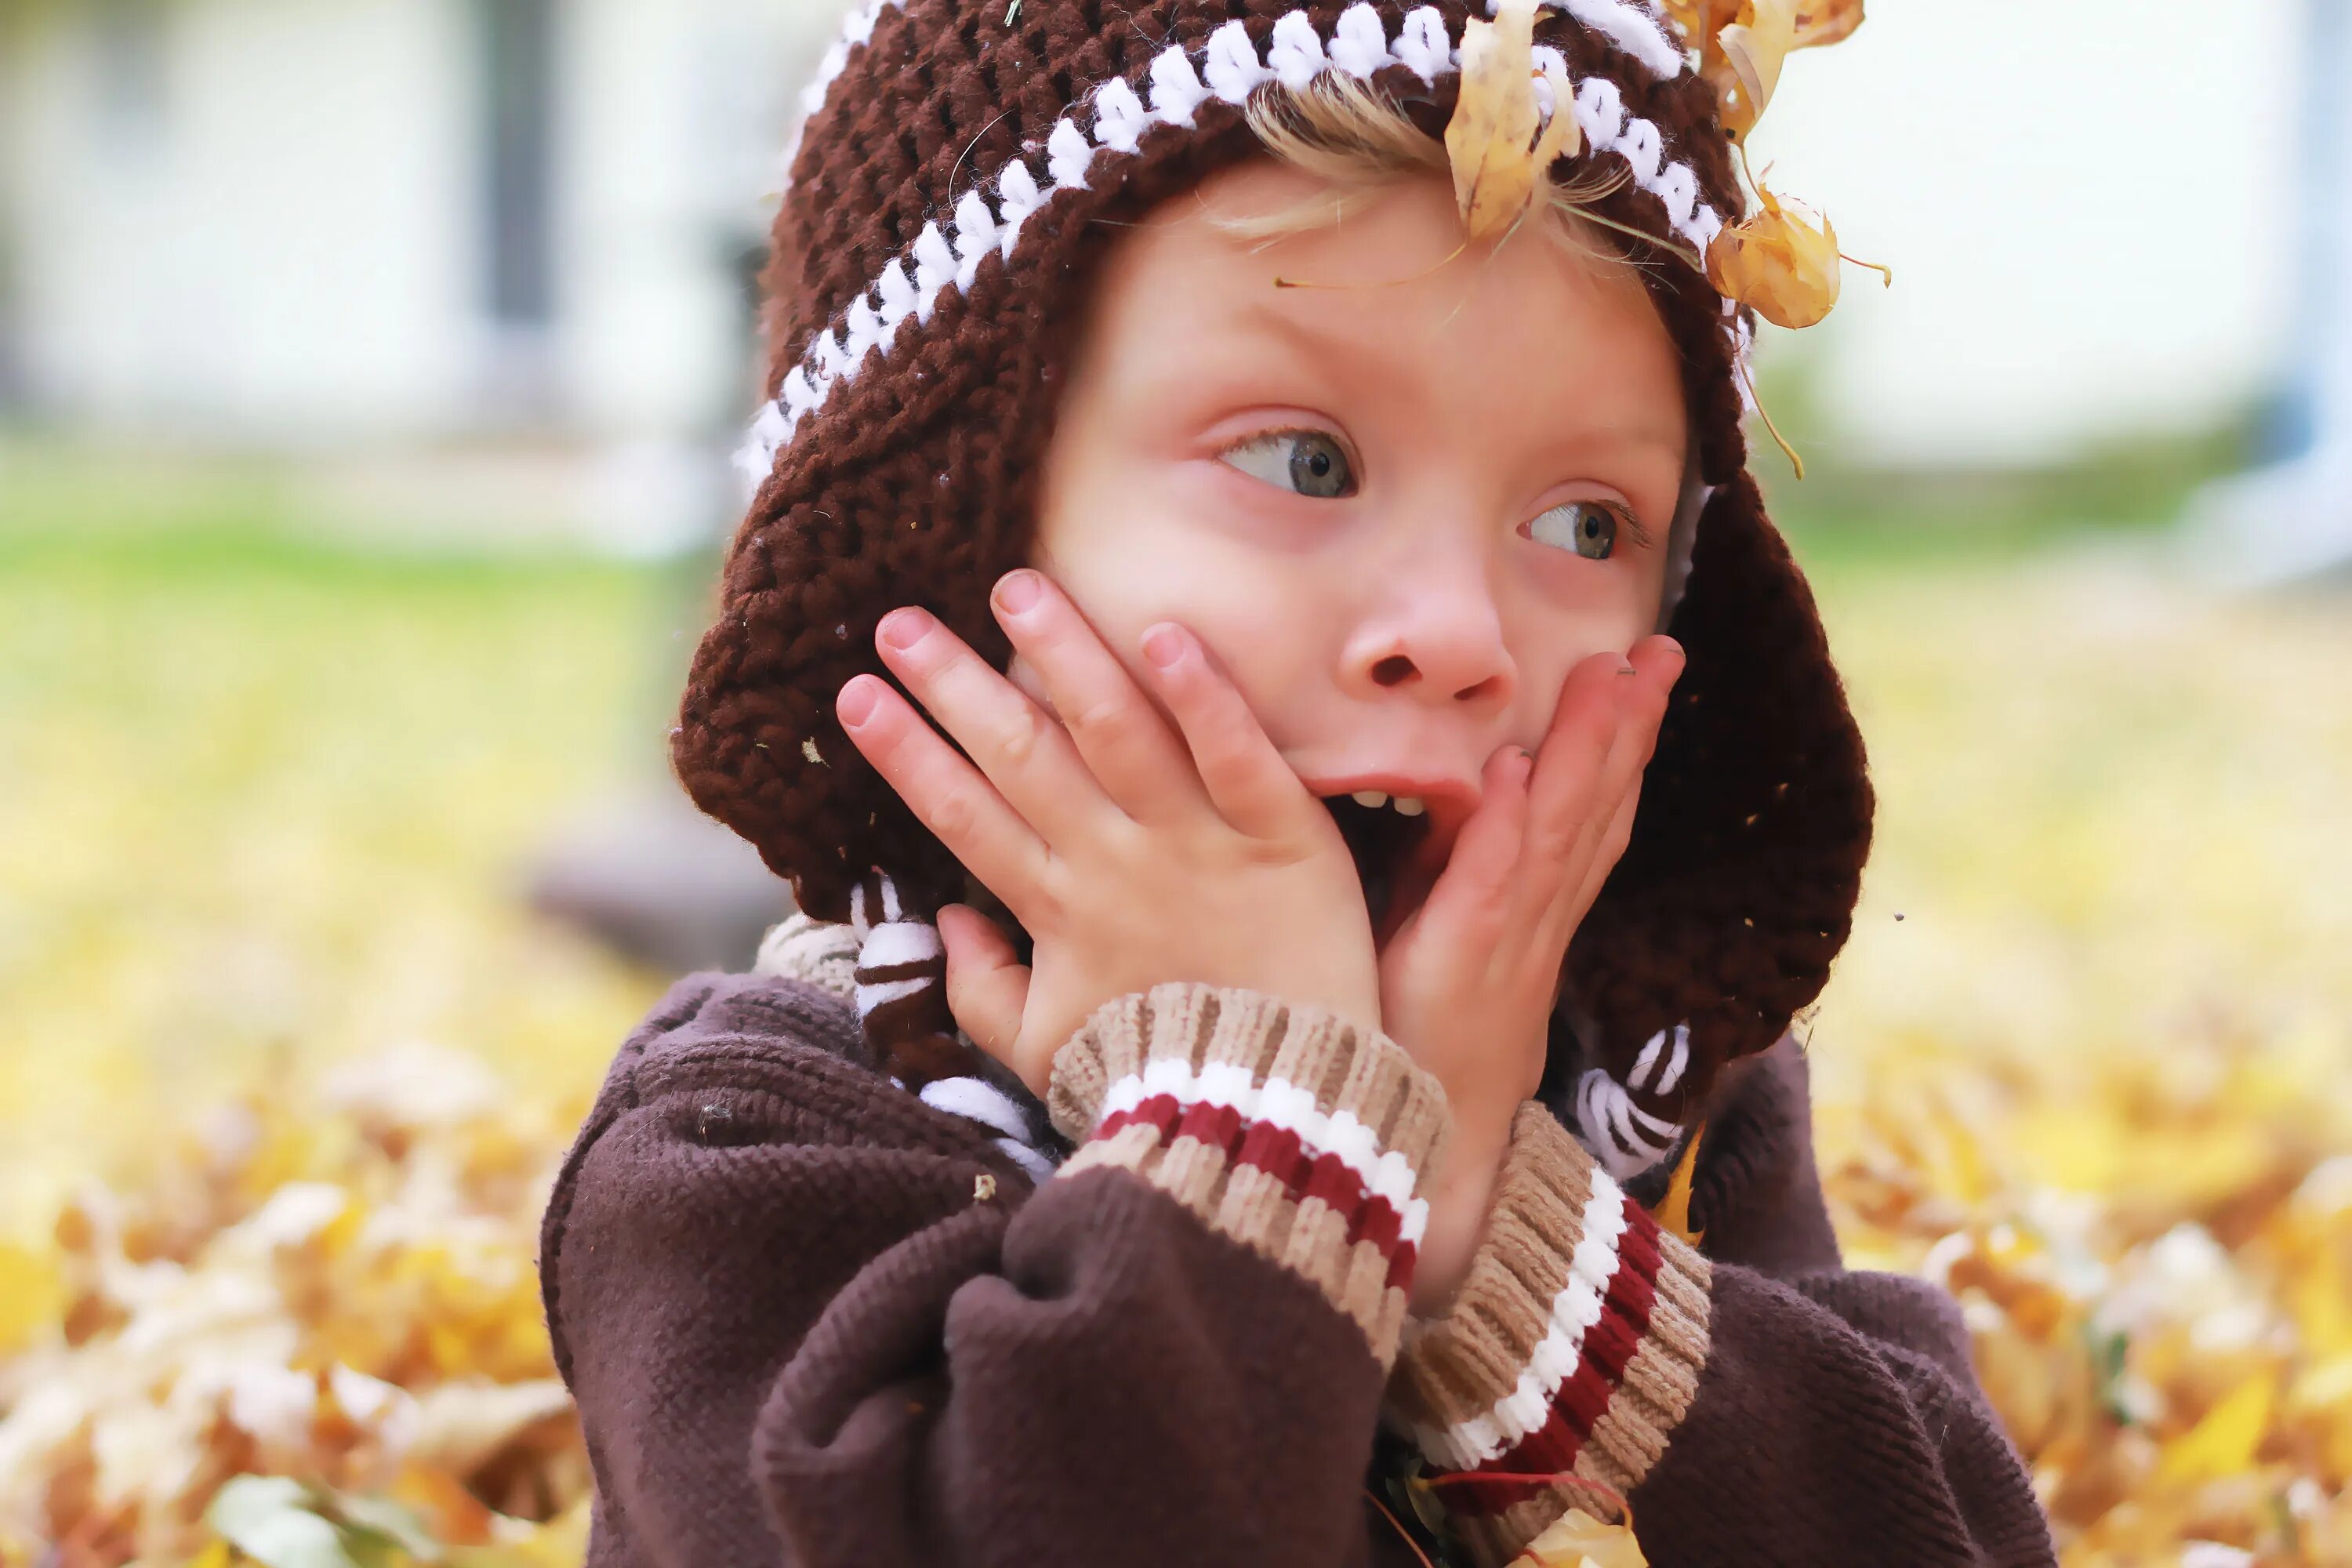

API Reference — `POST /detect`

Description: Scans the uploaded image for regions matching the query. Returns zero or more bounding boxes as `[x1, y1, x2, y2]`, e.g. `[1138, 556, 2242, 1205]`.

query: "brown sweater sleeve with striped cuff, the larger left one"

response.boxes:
[541, 975, 1444, 1568]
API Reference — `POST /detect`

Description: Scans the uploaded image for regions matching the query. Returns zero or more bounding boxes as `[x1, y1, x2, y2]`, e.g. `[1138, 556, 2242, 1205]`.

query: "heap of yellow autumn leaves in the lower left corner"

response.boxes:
[0, 1046, 588, 1568]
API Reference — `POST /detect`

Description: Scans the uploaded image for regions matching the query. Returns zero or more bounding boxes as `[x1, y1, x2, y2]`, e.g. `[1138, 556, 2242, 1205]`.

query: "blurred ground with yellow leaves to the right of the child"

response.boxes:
[1811, 560, 2352, 1568]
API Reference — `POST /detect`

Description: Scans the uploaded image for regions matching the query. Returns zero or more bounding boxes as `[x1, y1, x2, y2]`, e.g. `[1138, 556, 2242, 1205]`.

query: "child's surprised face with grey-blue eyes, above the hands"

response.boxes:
[1035, 160, 1686, 869]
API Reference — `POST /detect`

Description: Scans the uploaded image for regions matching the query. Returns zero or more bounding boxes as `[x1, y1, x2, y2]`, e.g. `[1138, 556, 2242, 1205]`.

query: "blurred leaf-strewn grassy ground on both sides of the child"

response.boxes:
[0, 466, 2352, 1568]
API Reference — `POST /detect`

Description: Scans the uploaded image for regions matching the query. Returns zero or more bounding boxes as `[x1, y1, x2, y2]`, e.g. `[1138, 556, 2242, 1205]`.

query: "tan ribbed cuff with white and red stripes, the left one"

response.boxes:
[1049, 985, 1446, 1366]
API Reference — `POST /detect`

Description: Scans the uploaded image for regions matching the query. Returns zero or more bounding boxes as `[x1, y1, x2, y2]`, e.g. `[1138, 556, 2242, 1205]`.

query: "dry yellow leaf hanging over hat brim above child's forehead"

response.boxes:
[1446, 0, 1583, 242]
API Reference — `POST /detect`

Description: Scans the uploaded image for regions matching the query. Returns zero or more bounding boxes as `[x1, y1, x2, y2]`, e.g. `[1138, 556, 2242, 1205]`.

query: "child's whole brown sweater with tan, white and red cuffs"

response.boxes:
[541, 926, 2053, 1568]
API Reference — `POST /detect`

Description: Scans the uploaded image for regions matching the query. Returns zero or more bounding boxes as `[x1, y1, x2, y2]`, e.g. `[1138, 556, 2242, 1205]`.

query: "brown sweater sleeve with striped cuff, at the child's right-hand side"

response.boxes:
[1390, 1105, 2056, 1568]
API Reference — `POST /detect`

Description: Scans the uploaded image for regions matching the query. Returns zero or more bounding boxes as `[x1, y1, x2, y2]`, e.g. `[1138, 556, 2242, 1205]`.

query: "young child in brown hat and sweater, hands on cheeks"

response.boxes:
[541, 0, 2053, 1568]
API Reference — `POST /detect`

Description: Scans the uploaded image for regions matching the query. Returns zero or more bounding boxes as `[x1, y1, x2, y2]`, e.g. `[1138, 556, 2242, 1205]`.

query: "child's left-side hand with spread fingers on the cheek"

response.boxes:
[837, 572, 1381, 1095]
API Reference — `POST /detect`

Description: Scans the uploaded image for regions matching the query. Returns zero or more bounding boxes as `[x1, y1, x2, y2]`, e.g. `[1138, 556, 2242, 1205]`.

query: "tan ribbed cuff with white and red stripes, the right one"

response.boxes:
[1390, 1102, 1712, 1563]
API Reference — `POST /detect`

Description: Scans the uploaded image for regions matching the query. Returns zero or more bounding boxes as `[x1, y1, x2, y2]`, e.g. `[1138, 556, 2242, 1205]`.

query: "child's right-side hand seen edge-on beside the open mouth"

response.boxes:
[1381, 637, 1684, 1312]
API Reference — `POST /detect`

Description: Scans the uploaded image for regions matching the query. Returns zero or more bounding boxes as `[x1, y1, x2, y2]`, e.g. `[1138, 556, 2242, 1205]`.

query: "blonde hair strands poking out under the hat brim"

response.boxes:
[1218, 71, 1642, 266]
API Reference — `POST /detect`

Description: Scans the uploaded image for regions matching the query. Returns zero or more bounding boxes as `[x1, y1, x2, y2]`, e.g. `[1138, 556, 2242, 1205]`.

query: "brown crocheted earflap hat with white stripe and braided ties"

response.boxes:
[675, 0, 1872, 1175]
